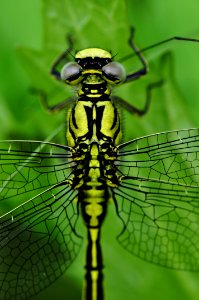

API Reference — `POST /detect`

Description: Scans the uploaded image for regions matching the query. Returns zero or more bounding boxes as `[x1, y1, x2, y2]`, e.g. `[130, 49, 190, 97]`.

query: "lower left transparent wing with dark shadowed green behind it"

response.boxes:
[0, 183, 81, 300]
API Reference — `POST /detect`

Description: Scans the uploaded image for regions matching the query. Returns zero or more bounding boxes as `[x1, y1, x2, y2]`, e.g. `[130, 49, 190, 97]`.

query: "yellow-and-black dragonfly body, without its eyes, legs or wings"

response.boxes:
[65, 48, 122, 300]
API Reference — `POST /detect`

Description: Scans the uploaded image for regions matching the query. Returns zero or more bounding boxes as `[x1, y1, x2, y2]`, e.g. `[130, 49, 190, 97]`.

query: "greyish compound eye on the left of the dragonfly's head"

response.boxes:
[61, 62, 82, 81]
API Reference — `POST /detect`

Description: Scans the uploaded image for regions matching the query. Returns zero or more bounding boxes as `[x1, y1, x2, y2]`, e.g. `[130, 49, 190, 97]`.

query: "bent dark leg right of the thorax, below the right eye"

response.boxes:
[113, 80, 164, 116]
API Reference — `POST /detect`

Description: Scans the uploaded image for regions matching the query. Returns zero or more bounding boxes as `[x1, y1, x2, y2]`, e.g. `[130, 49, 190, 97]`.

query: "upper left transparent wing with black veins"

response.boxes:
[0, 141, 75, 209]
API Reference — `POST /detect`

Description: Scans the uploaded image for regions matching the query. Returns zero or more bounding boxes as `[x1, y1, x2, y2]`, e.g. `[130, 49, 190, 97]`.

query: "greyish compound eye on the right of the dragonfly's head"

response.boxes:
[102, 61, 126, 82]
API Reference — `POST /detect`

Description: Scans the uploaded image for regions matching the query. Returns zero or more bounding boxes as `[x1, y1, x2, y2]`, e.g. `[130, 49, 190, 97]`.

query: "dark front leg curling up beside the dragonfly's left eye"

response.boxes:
[50, 35, 73, 80]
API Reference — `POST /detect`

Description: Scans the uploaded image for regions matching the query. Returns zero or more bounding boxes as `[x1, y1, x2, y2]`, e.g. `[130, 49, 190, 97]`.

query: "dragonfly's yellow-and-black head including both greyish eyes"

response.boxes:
[61, 48, 126, 89]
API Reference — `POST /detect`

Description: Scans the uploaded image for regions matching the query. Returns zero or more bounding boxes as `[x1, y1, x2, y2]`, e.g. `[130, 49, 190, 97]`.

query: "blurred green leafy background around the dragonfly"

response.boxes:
[0, 0, 199, 300]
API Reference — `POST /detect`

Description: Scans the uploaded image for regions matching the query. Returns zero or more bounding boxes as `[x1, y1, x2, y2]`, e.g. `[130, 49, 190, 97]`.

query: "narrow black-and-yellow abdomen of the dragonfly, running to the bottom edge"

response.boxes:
[79, 143, 109, 300]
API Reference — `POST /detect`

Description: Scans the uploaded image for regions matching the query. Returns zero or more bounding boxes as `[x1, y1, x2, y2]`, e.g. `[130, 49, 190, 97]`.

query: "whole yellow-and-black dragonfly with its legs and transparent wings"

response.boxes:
[0, 29, 199, 300]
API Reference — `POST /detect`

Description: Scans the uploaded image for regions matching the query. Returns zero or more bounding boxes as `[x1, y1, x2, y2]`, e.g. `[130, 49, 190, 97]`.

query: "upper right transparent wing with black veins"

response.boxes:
[116, 129, 199, 186]
